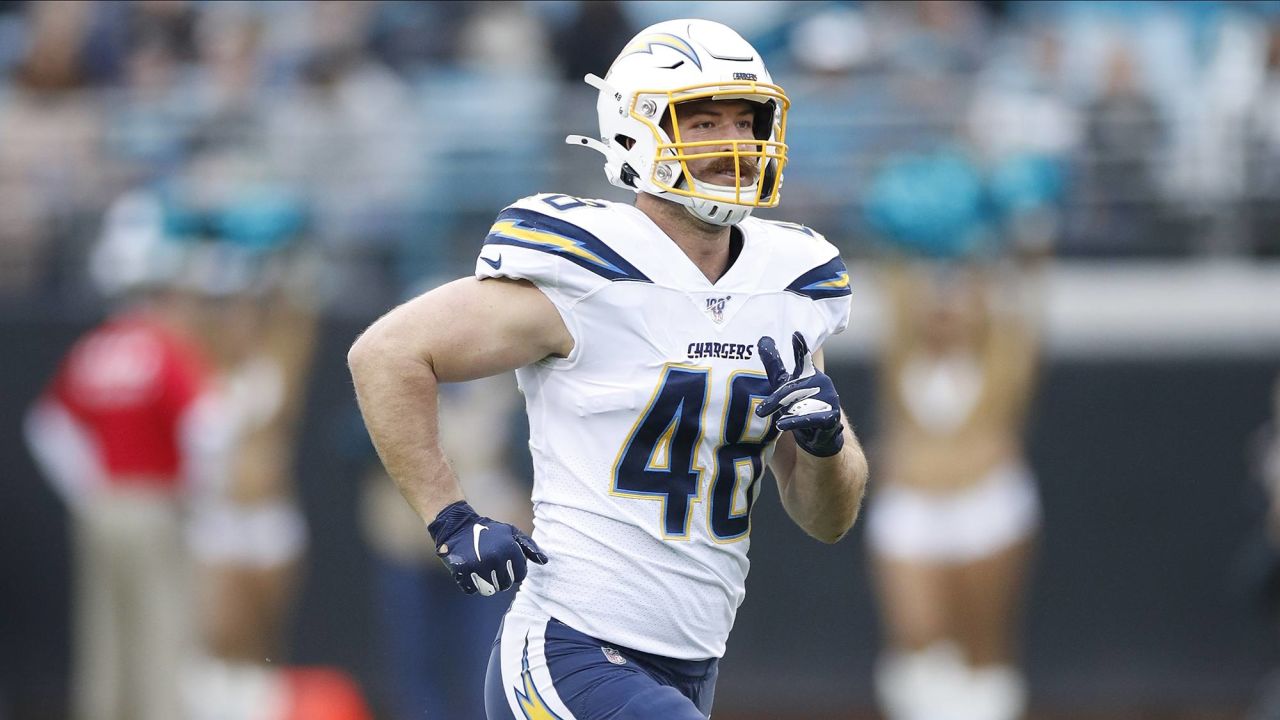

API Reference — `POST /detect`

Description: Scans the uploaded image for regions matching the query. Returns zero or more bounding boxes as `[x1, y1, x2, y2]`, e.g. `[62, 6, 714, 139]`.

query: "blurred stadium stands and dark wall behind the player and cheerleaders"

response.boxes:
[0, 0, 1280, 720]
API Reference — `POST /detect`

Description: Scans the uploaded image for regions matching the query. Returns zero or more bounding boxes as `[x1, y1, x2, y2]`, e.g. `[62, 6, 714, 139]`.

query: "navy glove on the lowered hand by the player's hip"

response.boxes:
[426, 500, 547, 596]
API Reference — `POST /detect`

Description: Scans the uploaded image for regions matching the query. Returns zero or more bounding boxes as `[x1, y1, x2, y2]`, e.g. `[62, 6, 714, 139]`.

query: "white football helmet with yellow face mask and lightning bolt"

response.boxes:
[564, 19, 791, 225]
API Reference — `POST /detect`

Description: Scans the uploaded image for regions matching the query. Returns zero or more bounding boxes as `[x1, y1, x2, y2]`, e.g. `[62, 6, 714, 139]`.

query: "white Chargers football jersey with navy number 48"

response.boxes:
[476, 195, 850, 660]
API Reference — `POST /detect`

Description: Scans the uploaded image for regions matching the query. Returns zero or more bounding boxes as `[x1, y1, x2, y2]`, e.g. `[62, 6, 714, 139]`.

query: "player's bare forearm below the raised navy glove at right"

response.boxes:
[769, 351, 868, 543]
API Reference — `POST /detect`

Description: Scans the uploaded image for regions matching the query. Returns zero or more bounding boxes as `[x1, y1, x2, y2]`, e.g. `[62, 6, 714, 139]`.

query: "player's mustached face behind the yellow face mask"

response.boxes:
[662, 100, 759, 187]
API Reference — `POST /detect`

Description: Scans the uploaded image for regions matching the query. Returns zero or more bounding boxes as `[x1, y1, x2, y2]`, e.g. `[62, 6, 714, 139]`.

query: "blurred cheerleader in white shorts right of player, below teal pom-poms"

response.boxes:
[867, 252, 1041, 720]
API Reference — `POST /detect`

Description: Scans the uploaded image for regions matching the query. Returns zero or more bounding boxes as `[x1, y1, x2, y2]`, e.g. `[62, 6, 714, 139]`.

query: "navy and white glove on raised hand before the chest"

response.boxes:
[755, 333, 845, 457]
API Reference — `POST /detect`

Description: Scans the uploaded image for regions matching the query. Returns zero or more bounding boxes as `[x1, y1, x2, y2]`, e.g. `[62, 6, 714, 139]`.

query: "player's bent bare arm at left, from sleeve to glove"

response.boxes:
[347, 278, 573, 521]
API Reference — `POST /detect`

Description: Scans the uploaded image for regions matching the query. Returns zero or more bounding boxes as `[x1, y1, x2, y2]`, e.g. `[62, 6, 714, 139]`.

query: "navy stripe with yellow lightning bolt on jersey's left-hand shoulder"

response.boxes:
[484, 208, 653, 282]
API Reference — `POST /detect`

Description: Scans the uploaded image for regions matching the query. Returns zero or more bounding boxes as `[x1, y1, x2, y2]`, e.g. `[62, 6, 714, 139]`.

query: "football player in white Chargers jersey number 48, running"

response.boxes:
[348, 20, 867, 720]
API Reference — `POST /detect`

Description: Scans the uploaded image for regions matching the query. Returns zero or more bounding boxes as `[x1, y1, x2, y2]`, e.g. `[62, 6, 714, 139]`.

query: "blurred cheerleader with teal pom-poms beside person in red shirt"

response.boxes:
[155, 163, 315, 706]
